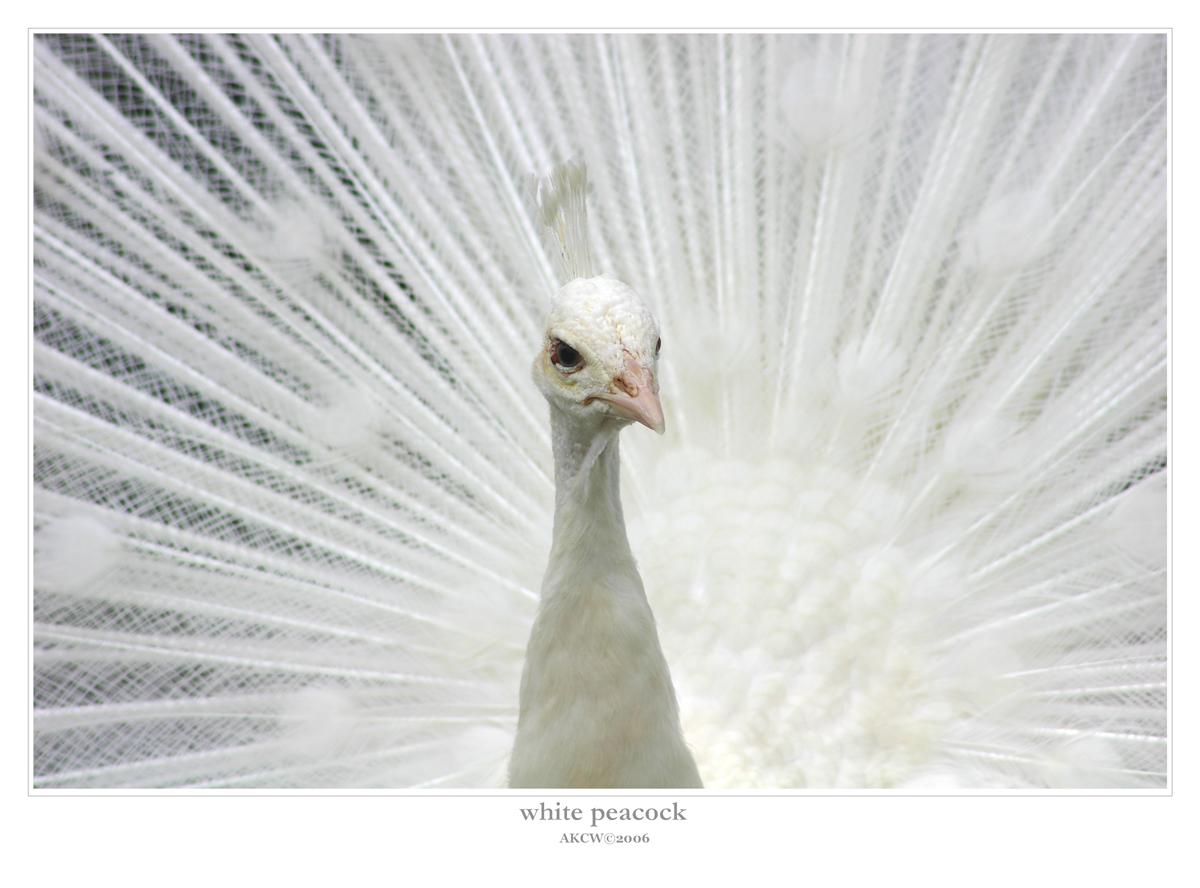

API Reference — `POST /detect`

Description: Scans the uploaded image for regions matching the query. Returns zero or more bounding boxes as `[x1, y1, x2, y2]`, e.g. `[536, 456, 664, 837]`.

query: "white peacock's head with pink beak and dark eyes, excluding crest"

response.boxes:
[533, 274, 666, 434]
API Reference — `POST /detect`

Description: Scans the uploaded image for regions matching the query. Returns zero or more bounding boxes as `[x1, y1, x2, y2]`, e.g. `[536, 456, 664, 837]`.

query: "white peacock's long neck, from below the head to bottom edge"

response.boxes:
[509, 402, 701, 788]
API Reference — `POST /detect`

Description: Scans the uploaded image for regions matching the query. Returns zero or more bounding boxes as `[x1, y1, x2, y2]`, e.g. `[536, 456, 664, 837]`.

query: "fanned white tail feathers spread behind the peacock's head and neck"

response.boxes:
[34, 35, 1168, 787]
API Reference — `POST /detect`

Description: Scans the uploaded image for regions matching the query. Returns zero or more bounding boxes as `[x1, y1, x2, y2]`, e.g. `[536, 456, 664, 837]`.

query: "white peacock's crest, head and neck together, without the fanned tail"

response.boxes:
[509, 164, 701, 788]
